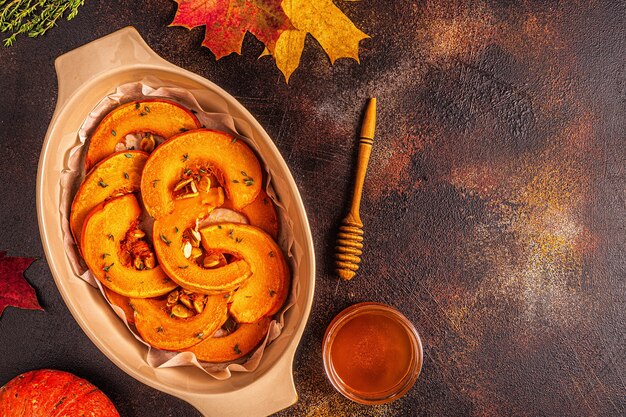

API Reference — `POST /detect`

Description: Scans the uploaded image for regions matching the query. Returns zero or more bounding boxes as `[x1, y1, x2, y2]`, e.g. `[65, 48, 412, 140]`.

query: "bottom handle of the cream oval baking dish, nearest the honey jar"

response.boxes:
[182, 352, 298, 417]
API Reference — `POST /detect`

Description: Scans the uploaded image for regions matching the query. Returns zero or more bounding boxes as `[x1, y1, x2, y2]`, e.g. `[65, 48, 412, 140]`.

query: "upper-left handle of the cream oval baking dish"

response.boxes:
[54, 26, 173, 109]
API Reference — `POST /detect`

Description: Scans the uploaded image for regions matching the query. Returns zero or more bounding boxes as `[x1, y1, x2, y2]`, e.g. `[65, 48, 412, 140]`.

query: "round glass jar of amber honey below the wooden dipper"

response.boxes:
[323, 303, 423, 404]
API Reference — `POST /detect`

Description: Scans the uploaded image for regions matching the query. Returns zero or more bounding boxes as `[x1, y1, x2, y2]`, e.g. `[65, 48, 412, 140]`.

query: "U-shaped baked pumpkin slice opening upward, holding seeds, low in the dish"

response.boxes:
[130, 295, 228, 350]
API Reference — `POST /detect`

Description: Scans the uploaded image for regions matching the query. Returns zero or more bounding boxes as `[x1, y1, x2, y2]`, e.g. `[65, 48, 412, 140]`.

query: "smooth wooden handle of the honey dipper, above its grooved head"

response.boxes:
[350, 98, 376, 218]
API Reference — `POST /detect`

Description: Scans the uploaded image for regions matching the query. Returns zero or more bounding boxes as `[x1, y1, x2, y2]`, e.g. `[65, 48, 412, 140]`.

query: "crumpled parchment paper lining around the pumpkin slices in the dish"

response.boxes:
[59, 77, 302, 379]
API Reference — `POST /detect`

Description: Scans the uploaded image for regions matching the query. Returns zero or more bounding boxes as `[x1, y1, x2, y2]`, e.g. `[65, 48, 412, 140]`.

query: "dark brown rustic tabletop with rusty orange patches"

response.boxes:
[0, 0, 626, 417]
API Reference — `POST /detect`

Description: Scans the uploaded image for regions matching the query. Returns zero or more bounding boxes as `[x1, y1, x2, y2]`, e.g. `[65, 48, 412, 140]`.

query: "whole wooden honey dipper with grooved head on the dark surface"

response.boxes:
[335, 98, 376, 280]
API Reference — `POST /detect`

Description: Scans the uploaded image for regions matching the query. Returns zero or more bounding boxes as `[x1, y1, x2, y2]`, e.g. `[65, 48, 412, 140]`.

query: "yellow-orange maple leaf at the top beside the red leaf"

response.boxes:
[263, 0, 369, 82]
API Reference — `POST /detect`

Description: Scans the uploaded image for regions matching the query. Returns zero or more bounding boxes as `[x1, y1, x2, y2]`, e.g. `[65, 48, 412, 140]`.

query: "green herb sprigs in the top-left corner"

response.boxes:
[0, 0, 85, 46]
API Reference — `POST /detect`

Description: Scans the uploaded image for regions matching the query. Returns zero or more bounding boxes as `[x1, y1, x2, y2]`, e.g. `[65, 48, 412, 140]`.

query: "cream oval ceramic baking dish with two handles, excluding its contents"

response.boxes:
[37, 27, 315, 417]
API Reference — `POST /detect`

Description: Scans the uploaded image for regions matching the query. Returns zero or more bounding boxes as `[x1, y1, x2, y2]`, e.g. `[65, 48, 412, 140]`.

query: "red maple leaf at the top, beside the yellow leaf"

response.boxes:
[171, 0, 293, 59]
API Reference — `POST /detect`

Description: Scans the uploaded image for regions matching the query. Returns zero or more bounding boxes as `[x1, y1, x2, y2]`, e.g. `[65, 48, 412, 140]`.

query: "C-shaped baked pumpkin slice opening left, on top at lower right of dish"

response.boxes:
[199, 223, 291, 323]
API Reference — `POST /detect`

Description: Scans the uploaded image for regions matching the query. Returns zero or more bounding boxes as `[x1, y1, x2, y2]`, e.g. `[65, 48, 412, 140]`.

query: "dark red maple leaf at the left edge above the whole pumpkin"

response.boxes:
[0, 252, 43, 316]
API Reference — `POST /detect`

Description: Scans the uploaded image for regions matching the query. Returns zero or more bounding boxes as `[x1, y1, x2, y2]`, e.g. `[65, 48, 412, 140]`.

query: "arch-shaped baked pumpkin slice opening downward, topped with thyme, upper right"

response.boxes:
[141, 129, 263, 219]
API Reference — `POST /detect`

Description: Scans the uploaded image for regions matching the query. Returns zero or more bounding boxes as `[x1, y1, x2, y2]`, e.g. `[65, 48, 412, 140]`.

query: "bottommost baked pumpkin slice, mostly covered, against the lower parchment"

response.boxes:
[188, 317, 272, 362]
